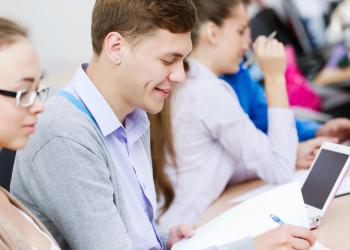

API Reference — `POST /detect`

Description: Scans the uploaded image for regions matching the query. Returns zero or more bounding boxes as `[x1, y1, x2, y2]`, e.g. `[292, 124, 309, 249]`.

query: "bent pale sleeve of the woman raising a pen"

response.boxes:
[195, 81, 297, 183]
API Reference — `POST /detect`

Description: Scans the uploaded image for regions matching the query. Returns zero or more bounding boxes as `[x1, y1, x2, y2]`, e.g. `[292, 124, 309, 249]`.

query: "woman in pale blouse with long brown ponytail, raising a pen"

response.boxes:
[151, 0, 298, 232]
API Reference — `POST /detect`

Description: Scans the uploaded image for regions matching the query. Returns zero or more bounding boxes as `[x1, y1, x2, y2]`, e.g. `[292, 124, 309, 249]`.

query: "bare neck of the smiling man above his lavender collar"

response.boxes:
[86, 60, 133, 123]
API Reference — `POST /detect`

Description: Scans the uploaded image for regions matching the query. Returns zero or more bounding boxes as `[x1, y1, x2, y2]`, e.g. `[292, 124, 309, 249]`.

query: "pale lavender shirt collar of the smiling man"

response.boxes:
[69, 64, 149, 143]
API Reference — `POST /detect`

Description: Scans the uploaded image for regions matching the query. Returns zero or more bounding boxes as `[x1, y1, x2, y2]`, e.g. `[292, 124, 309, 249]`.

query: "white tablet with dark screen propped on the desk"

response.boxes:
[301, 142, 350, 228]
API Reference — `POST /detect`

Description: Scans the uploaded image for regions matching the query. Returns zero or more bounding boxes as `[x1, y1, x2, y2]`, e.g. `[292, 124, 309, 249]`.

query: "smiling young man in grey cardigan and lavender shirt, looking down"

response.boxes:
[11, 0, 196, 250]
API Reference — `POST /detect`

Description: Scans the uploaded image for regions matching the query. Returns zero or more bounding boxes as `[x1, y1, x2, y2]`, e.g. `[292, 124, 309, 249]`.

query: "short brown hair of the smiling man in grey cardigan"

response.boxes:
[91, 0, 196, 55]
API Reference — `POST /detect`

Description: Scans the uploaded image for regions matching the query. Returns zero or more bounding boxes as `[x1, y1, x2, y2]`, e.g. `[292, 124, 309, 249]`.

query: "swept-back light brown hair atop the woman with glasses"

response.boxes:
[0, 17, 28, 48]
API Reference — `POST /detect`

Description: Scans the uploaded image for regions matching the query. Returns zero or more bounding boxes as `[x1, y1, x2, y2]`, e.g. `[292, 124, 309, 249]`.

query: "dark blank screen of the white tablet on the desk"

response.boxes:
[301, 149, 349, 210]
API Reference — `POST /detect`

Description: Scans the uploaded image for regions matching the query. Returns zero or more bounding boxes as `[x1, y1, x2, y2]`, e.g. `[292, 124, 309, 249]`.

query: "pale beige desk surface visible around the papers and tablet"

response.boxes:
[196, 180, 350, 250]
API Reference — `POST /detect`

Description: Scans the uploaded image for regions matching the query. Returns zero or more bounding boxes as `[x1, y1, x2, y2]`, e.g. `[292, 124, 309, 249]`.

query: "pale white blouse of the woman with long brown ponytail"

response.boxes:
[160, 60, 298, 230]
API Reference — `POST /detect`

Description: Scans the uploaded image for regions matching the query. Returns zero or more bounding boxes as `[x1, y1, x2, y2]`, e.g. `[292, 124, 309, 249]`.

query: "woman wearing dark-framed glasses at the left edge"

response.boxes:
[0, 18, 59, 250]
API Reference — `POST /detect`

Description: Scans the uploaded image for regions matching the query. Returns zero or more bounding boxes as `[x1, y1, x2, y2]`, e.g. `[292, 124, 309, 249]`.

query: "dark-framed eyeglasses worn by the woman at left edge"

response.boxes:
[0, 86, 50, 108]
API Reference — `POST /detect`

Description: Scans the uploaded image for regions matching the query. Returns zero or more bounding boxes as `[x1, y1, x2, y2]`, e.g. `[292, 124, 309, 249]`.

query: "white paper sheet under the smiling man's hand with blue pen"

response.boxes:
[172, 182, 309, 250]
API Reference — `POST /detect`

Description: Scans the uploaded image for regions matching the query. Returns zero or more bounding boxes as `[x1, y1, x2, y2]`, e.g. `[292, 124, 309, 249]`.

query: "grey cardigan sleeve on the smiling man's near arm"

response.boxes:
[28, 137, 132, 250]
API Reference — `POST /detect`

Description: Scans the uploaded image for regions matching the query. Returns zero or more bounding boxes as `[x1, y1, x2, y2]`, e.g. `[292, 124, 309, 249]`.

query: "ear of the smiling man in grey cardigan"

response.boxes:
[104, 32, 125, 65]
